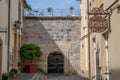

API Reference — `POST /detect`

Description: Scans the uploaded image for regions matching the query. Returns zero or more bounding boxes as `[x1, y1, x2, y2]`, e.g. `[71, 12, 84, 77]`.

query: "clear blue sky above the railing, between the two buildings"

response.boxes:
[26, 0, 80, 9]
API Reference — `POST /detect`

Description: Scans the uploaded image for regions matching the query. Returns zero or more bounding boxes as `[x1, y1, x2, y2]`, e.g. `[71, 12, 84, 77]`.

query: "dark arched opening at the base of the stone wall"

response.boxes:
[48, 52, 64, 73]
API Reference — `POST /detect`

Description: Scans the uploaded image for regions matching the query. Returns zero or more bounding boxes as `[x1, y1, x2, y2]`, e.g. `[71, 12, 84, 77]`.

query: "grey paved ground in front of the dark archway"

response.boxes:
[44, 73, 85, 80]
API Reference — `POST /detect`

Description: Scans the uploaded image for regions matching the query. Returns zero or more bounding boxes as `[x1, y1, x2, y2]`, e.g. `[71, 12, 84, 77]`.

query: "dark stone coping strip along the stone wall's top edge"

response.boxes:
[24, 16, 81, 20]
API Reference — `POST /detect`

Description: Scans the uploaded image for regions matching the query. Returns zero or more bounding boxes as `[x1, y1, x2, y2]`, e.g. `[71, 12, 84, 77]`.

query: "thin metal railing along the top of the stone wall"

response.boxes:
[24, 9, 80, 17]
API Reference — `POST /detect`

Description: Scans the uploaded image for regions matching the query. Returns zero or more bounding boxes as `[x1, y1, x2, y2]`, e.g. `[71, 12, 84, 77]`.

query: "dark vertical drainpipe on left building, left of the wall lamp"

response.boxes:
[7, 0, 11, 72]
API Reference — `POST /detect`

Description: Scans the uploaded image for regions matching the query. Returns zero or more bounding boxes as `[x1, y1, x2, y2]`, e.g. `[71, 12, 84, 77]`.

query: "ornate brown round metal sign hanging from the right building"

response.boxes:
[88, 8, 110, 33]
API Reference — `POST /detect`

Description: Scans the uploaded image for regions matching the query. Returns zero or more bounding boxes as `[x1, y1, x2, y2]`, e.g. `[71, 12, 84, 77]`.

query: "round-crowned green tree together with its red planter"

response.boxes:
[20, 44, 42, 72]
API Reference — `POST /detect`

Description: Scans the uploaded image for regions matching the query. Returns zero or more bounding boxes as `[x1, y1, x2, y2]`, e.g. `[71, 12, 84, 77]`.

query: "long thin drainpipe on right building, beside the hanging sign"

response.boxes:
[87, 0, 91, 80]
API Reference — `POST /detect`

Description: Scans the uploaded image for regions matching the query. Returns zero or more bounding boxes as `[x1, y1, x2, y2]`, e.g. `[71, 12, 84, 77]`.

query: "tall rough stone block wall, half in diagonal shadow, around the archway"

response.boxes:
[23, 17, 80, 73]
